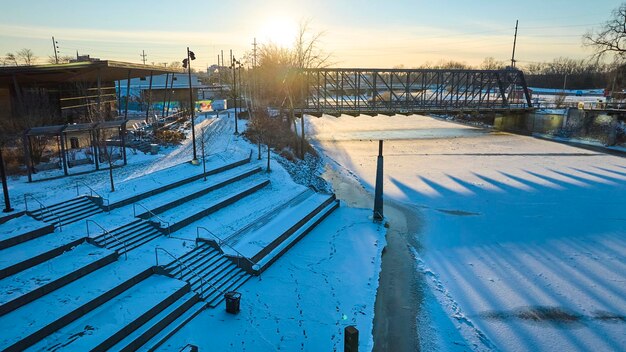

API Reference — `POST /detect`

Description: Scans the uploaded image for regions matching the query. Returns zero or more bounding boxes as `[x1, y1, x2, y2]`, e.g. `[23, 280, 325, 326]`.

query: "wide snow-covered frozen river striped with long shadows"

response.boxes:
[307, 115, 626, 351]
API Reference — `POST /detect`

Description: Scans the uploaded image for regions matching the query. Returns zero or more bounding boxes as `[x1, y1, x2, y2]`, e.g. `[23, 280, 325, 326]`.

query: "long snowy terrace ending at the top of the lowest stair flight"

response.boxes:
[0, 260, 153, 351]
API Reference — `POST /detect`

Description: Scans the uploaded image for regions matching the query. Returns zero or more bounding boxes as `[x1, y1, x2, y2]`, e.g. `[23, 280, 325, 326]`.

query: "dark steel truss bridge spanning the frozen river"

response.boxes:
[302, 68, 532, 116]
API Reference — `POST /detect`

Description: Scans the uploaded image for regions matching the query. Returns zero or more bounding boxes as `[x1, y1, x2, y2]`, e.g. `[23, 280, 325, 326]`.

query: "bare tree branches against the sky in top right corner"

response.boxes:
[583, 2, 626, 60]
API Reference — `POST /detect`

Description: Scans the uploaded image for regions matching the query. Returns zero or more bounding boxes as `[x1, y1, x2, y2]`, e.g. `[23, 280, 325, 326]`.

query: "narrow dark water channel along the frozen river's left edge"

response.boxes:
[324, 168, 423, 351]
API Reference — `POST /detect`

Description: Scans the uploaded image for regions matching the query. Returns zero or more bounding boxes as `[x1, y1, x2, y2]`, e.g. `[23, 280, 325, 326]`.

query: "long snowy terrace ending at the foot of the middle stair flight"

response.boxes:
[0, 243, 118, 316]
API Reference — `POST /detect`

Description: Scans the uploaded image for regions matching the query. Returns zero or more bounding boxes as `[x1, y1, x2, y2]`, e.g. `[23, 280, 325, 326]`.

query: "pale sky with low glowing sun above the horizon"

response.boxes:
[0, 0, 623, 68]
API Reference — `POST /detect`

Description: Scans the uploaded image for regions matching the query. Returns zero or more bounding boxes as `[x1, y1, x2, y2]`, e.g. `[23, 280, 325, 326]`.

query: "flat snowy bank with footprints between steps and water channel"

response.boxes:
[162, 207, 385, 351]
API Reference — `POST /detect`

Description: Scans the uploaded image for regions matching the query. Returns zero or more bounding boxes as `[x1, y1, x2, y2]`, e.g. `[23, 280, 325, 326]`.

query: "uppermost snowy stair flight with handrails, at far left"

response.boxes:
[29, 197, 103, 225]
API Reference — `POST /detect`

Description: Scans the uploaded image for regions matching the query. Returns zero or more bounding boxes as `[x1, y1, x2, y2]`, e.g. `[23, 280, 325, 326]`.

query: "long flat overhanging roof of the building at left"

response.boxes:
[0, 60, 180, 86]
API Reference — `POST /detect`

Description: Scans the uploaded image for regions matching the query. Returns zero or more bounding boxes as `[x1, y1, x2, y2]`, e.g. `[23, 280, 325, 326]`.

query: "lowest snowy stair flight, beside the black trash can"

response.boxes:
[158, 243, 251, 307]
